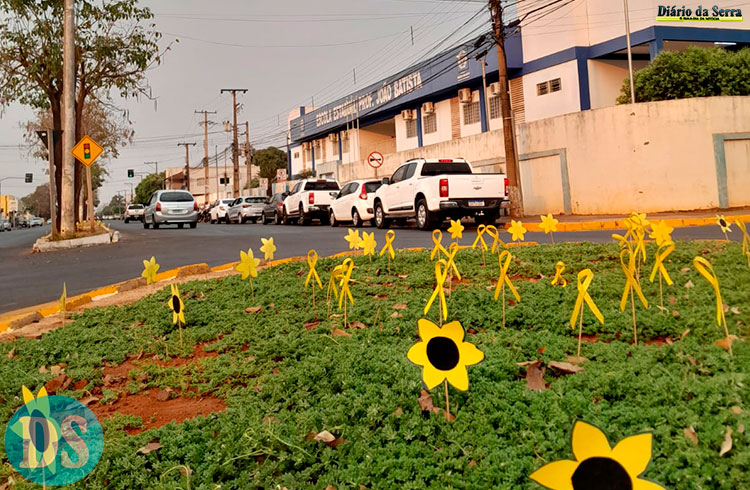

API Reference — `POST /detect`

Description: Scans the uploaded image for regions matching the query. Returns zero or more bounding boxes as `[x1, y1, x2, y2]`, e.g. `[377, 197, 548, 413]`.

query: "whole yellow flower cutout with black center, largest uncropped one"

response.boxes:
[406, 318, 484, 391]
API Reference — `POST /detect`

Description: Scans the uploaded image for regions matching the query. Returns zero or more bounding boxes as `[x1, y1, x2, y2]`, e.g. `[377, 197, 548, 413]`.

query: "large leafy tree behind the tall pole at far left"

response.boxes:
[0, 0, 170, 236]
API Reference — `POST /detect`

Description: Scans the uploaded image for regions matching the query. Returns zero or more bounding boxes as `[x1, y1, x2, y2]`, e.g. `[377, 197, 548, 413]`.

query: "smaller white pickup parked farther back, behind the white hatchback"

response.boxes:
[282, 179, 340, 225]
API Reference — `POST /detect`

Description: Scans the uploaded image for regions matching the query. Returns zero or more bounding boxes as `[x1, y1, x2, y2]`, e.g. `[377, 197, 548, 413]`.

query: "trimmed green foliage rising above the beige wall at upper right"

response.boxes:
[617, 46, 750, 104]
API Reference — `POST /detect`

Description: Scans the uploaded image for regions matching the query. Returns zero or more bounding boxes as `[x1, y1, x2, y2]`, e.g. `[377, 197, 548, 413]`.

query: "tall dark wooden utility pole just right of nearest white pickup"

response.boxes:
[489, 0, 523, 218]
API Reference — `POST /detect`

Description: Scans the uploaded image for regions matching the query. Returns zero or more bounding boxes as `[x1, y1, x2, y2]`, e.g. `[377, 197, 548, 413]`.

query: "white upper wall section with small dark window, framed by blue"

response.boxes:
[523, 60, 581, 122]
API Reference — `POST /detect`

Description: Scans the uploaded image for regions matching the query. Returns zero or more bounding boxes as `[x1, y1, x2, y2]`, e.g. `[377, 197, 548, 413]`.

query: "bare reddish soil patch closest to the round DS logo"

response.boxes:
[89, 388, 227, 436]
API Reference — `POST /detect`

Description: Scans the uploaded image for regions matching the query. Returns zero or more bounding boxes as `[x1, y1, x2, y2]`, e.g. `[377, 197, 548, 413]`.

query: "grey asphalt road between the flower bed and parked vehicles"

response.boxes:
[0, 221, 740, 313]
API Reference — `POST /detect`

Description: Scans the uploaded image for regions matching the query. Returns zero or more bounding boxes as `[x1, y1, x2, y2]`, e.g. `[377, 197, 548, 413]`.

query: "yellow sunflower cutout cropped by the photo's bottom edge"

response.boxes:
[529, 420, 665, 490]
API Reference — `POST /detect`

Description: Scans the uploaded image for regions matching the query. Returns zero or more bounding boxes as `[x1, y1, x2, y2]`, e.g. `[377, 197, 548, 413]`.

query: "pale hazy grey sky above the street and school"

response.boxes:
[0, 0, 489, 203]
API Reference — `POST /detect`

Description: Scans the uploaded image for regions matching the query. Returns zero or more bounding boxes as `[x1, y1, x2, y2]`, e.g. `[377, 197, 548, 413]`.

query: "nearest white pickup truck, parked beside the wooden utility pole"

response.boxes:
[374, 158, 508, 230]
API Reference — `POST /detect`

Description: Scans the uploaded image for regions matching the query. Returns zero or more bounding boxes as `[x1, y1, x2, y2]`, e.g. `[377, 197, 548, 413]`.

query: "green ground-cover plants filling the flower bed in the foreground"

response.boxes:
[0, 242, 750, 490]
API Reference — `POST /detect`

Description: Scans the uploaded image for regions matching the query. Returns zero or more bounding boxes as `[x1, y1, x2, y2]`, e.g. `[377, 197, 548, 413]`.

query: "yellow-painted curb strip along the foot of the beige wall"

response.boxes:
[516, 208, 750, 232]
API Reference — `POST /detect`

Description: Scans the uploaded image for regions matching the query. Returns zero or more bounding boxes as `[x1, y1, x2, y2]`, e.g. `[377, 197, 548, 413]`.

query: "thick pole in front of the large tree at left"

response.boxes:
[61, 0, 76, 236]
